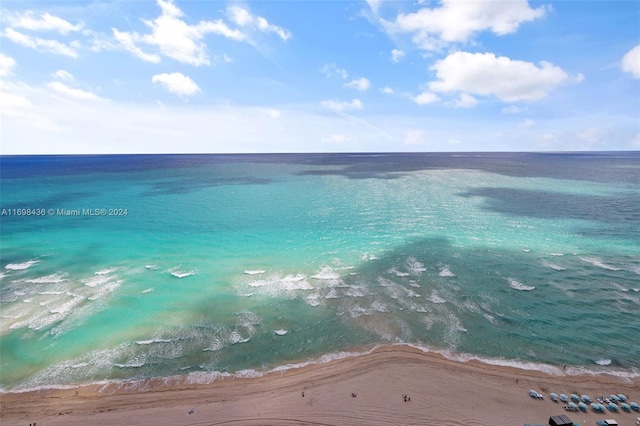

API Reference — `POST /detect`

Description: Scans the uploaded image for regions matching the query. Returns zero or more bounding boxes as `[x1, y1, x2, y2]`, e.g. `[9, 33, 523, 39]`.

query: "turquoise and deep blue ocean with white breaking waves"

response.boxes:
[0, 152, 640, 392]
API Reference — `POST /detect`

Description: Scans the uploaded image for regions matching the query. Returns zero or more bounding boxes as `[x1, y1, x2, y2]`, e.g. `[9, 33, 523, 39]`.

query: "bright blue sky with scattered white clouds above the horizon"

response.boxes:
[0, 0, 640, 155]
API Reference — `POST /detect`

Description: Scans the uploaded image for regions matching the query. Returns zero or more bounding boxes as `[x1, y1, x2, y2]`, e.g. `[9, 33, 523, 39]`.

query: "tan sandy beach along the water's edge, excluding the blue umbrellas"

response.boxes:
[0, 346, 640, 426]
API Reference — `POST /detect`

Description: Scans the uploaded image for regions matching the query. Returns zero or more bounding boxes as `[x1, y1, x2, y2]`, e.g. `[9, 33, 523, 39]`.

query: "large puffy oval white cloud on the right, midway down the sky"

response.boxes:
[429, 50, 568, 102]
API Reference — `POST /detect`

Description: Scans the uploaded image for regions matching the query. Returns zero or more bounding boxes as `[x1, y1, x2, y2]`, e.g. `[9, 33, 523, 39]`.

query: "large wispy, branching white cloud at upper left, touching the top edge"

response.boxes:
[112, 0, 247, 66]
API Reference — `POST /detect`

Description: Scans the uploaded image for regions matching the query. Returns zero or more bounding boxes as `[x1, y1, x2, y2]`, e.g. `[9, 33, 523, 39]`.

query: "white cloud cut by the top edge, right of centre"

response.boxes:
[381, 0, 547, 50]
